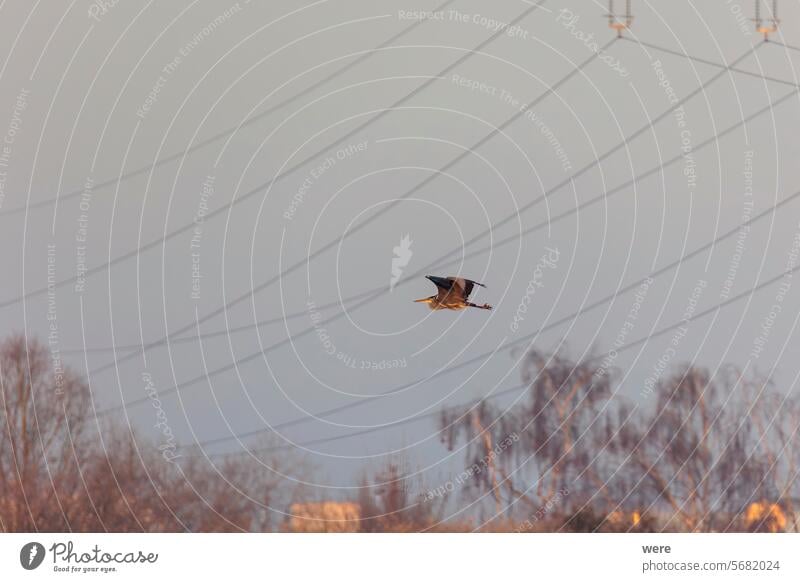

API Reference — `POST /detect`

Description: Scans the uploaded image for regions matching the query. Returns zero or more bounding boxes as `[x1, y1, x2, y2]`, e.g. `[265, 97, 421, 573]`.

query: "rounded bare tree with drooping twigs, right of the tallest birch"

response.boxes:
[622, 368, 768, 531]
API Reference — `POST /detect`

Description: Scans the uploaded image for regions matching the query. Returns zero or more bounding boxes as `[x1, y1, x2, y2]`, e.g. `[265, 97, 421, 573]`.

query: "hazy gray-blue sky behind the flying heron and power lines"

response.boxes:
[0, 0, 800, 498]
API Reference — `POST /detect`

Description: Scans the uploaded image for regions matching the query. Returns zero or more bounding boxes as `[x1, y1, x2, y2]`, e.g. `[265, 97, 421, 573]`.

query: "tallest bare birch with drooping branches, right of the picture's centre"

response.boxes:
[440, 350, 613, 514]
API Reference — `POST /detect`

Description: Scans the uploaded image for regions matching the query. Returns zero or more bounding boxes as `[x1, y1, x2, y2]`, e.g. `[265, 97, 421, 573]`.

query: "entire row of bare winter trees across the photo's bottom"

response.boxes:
[0, 335, 800, 532]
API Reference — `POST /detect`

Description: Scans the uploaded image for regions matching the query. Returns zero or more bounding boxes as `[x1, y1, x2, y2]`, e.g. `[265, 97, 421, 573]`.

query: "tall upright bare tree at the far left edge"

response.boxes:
[0, 335, 93, 531]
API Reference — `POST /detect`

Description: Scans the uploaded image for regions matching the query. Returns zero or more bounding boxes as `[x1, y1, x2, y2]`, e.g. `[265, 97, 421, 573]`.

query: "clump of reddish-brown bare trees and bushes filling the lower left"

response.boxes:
[0, 336, 304, 532]
